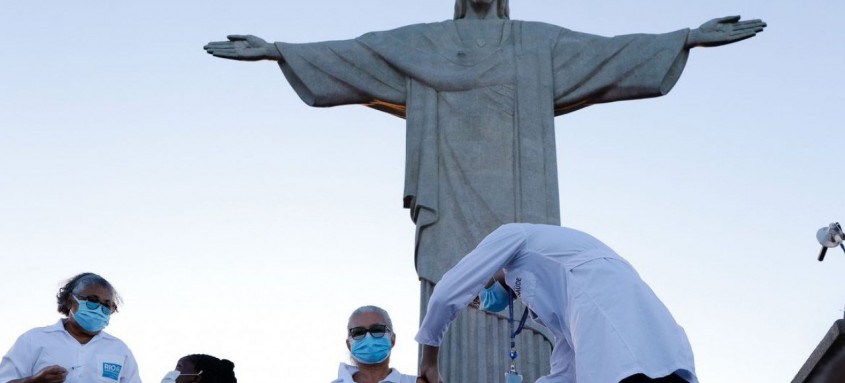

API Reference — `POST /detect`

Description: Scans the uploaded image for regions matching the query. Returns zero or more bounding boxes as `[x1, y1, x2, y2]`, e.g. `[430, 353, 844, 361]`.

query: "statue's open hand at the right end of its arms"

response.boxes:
[686, 16, 766, 49]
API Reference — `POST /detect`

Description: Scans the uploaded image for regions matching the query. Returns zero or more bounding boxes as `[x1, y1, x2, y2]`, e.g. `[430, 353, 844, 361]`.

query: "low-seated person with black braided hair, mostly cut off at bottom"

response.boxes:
[161, 354, 238, 383]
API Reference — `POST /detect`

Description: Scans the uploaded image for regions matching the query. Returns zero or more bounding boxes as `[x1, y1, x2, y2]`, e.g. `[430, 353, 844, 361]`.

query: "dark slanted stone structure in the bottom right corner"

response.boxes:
[792, 319, 845, 383]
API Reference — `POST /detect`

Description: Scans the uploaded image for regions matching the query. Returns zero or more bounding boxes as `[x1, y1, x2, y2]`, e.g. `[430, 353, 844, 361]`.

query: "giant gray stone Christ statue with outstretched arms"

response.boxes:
[204, 0, 766, 382]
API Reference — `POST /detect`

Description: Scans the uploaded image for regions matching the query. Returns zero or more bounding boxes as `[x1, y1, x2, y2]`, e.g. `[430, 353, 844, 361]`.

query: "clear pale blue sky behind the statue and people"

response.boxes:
[0, 0, 845, 383]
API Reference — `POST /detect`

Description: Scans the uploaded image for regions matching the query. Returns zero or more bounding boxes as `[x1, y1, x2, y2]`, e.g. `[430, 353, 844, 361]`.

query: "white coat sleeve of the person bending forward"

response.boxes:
[415, 224, 526, 346]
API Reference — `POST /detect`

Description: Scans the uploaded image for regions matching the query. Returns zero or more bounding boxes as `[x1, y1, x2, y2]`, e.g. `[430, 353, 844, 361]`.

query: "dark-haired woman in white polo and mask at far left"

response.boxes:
[0, 273, 141, 383]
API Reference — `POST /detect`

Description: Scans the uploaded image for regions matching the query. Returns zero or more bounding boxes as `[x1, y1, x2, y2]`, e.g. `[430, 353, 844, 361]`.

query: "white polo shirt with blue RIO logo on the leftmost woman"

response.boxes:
[0, 320, 141, 383]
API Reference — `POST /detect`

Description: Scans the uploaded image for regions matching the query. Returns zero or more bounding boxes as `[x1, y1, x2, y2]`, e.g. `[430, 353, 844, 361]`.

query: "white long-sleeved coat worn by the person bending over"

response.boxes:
[416, 223, 698, 383]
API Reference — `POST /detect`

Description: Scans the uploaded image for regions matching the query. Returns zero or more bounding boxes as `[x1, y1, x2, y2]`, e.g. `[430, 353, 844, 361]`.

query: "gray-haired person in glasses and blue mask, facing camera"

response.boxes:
[332, 306, 417, 383]
